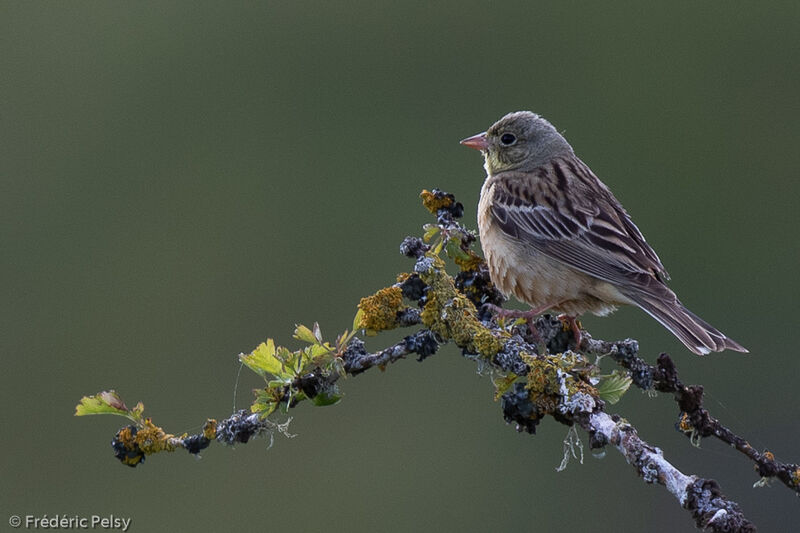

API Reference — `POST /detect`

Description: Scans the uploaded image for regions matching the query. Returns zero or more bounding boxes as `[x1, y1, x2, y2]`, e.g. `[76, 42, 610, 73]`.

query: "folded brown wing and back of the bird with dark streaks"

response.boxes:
[492, 158, 669, 292]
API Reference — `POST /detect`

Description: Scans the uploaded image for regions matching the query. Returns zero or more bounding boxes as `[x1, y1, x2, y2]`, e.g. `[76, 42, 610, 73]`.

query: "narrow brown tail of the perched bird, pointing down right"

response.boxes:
[627, 287, 748, 355]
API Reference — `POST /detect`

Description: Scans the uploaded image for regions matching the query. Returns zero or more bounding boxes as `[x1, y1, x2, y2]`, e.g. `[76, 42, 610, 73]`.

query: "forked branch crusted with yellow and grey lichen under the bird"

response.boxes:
[76, 190, 800, 531]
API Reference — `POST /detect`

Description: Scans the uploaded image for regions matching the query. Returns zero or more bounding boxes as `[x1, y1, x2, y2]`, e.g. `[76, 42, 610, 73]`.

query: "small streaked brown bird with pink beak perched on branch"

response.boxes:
[461, 111, 748, 355]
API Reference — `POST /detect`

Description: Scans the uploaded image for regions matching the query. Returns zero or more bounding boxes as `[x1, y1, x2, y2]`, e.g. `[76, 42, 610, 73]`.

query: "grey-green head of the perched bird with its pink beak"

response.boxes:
[461, 111, 573, 174]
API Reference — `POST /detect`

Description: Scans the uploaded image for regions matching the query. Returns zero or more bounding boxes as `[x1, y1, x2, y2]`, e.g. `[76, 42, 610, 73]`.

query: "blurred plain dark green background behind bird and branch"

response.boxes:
[0, 1, 800, 532]
